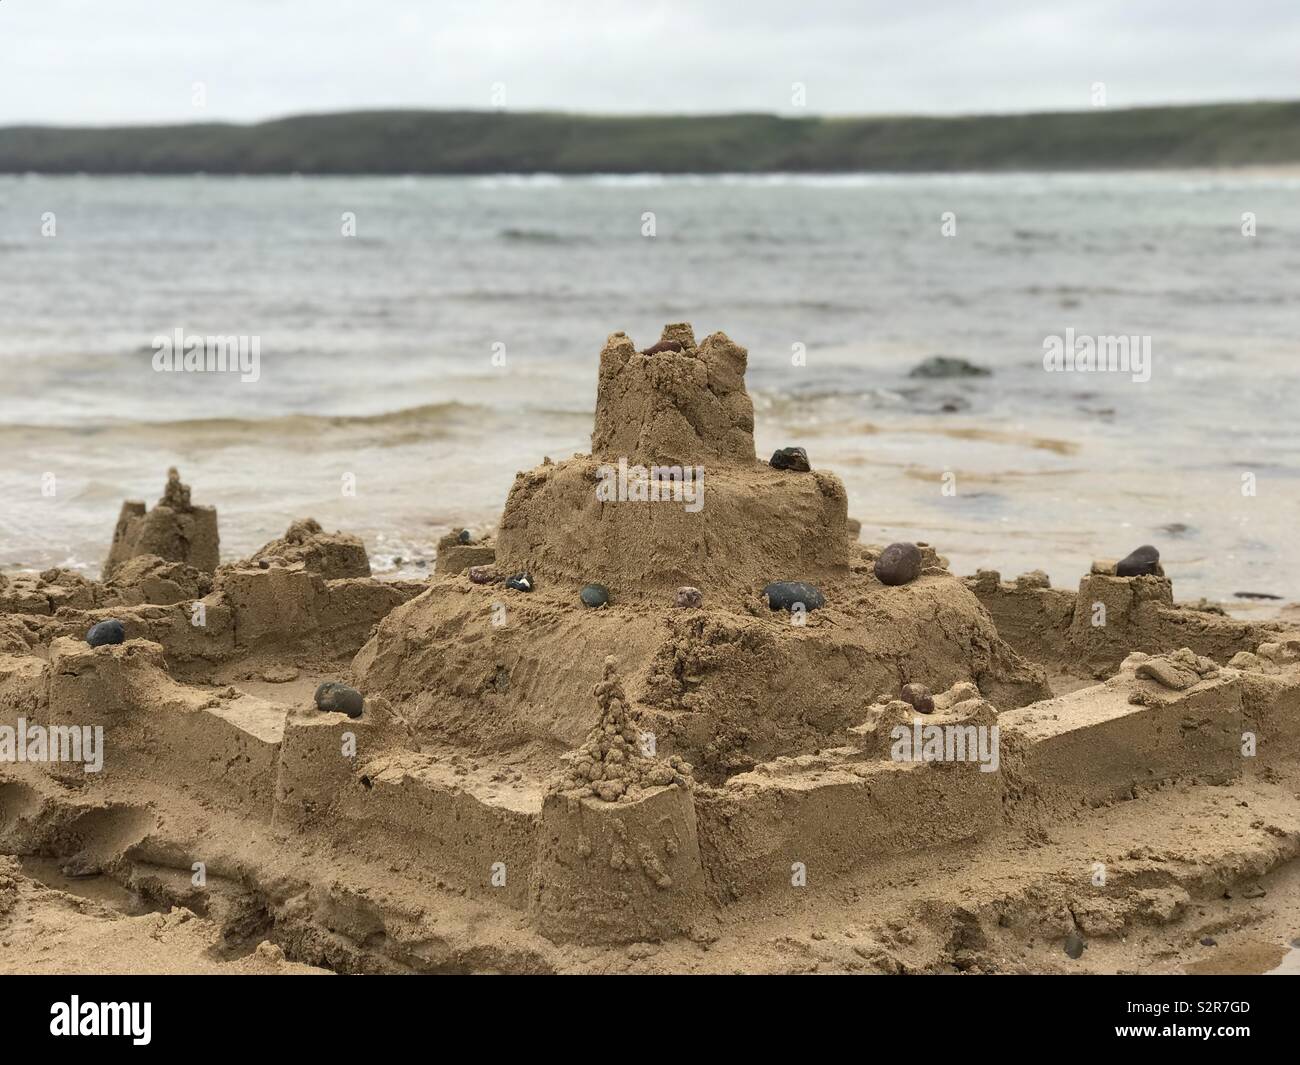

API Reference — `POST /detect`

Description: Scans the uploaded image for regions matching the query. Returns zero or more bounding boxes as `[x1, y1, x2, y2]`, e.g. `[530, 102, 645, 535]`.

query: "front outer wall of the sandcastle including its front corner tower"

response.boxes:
[0, 621, 1300, 944]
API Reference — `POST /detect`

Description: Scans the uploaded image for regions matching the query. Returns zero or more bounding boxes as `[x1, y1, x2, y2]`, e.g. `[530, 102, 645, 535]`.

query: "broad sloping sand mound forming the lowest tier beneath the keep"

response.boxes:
[352, 573, 1049, 779]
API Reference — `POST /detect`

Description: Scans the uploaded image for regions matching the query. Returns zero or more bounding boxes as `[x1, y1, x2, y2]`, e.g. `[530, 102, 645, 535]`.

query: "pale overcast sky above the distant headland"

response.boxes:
[0, 0, 1300, 125]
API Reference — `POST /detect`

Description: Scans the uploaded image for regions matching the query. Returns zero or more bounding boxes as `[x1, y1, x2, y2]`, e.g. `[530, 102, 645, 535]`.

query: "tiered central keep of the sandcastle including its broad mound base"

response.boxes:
[352, 324, 1047, 780]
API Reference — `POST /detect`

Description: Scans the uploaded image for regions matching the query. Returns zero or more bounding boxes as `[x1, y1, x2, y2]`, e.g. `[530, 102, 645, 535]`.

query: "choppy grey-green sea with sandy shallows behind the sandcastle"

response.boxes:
[0, 170, 1300, 612]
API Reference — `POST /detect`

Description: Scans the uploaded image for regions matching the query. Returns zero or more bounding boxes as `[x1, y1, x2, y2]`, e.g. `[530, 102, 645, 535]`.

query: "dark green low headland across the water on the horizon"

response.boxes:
[0, 101, 1300, 176]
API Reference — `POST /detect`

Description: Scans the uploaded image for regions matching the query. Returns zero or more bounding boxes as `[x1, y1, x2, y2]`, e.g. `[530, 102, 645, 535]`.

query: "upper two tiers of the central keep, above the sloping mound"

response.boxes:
[498, 324, 849, 596]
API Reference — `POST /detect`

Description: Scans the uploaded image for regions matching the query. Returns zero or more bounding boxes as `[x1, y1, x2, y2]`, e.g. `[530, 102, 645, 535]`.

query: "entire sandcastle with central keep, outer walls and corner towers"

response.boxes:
[0, 325, 1300, 973]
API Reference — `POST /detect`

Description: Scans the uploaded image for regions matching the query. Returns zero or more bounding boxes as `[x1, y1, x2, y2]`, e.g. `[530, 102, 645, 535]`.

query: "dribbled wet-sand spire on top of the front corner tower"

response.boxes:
[550, 655, 690, 802]
